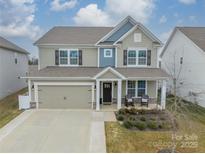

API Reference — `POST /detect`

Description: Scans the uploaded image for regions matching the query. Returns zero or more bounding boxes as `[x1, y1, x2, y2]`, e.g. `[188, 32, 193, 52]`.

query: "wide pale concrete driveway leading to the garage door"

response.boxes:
[0, 110, 95, 152]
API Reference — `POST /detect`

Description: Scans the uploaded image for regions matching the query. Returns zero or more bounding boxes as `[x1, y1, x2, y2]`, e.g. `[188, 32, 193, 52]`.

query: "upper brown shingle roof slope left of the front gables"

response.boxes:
[34, 26, 113, 45]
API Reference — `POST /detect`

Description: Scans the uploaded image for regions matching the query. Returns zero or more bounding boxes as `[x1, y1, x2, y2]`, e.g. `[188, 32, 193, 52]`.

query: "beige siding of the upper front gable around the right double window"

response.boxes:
[117, 29, 157, 67]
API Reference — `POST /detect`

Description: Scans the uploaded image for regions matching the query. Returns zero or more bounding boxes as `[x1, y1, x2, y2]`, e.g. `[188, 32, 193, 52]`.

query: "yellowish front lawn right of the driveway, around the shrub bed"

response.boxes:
[105, 97, 205, 152]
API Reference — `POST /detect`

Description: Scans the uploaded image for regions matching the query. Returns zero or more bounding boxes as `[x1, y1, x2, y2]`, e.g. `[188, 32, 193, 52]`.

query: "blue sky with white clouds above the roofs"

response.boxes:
[0, 0, 205, 57]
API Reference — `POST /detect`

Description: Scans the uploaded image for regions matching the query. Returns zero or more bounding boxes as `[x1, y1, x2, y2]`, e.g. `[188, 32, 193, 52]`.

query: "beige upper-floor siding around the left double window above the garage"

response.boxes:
[39, 46, 98, 69]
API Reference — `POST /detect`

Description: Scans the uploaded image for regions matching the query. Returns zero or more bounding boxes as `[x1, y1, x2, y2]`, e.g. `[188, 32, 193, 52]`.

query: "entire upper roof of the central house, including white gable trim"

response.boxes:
[34, 16, 162, 45]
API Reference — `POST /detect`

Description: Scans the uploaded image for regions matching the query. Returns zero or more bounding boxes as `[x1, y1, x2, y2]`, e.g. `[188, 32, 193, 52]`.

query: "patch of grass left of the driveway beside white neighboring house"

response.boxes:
[0, 88, 27, 128]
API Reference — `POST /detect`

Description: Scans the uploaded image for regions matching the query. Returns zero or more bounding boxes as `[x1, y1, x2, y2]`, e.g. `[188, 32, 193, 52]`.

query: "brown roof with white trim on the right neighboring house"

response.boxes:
[160, 27, 205, 57]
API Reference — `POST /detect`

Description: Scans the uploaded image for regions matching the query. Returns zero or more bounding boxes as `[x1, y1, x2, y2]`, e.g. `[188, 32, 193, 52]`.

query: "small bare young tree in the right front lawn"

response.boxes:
[164, 50, 192, 152]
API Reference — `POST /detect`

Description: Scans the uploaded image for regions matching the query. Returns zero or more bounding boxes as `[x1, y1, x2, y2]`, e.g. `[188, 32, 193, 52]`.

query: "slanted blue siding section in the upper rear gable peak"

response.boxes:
[105, 21, 134, 42]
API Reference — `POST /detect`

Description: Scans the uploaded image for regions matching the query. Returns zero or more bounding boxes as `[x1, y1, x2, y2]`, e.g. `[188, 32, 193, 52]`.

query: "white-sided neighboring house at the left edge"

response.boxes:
[0, 36, 28, 99]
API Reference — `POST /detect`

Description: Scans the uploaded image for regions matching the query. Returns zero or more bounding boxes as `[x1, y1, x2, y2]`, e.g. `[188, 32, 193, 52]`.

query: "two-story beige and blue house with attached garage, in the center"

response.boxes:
[25, 16, 168, 110]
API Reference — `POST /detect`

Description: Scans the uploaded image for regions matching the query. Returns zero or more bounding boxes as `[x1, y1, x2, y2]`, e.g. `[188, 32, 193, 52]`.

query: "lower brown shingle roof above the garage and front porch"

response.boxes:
[29, 66, 169, 78]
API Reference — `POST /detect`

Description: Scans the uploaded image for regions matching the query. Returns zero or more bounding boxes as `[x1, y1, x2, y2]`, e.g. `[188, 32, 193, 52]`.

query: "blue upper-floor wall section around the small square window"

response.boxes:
[99, 48, 115, 67]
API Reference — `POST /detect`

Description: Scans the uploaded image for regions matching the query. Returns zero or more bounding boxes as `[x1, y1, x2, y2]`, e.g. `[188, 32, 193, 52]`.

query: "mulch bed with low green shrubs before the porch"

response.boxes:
[115, 108, 174, 131]
